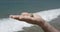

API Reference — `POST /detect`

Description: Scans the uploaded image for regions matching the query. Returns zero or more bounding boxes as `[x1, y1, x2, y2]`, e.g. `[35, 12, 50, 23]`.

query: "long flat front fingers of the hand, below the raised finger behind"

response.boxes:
[10, 15, 33, 21]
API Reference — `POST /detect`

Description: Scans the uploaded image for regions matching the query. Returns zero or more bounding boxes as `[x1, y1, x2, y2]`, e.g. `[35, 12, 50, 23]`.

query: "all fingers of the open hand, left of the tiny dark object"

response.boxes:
[9, 12, 34, 21]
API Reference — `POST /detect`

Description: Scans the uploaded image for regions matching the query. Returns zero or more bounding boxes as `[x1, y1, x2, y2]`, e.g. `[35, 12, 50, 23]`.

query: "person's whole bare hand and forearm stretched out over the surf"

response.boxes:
[10, 12, 60, 32]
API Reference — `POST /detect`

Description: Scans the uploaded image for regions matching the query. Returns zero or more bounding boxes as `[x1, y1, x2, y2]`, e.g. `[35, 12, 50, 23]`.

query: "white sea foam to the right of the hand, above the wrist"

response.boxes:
[36, 9, 60, 22]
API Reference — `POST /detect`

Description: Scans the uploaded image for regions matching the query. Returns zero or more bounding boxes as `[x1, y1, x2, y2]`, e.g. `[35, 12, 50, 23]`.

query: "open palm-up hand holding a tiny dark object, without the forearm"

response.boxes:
[10, 12, 43, 24]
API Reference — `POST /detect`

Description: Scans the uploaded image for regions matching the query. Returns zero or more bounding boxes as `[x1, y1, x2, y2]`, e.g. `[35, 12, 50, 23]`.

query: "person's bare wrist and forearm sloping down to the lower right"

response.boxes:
[37, 21, 59, 32]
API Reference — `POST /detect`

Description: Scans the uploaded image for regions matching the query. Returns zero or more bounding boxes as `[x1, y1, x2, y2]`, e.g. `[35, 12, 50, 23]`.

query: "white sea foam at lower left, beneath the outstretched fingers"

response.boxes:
[0, 18, 32, 32]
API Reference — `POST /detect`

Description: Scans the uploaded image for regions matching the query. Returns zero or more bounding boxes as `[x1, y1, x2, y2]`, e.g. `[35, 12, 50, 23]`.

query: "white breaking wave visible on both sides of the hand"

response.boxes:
[0, 9, 60, 32]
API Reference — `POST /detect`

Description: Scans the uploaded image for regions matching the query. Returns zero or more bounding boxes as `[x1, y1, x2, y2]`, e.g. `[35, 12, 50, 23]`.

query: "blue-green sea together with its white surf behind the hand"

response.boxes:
[0, 0, 60, 32]
